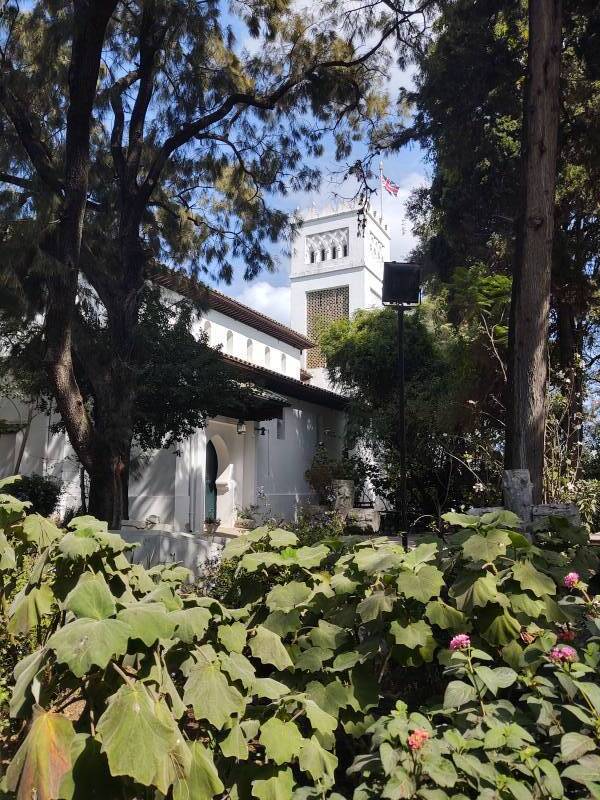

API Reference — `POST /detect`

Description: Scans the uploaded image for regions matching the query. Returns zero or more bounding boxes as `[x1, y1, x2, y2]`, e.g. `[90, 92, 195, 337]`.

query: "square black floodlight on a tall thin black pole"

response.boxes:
[381, 261, 421, 547]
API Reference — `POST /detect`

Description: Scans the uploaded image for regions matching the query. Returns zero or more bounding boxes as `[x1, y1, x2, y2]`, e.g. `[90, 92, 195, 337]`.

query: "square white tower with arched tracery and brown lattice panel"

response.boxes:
[290, 205, 390, 388]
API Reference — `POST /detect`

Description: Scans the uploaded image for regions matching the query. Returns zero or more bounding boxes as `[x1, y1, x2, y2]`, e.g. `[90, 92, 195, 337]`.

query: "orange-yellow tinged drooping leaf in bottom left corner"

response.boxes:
[5, 708, 75, 800]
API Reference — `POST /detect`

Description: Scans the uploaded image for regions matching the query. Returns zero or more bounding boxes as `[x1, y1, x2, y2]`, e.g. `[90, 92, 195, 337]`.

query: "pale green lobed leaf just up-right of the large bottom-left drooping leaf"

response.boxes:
[183, 662, 246, 728]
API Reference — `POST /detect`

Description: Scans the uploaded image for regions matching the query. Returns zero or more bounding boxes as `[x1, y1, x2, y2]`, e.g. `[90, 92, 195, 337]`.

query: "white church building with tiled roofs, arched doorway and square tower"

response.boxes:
[0, 207, 390, 533]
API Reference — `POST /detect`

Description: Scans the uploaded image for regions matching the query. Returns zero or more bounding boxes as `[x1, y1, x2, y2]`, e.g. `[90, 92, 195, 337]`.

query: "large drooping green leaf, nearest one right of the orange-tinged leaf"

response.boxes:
[97, 681, 191, 794]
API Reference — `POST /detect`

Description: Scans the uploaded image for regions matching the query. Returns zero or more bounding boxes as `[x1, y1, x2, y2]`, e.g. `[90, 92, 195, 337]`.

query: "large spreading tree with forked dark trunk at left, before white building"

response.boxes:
[0, 0, 432, 526]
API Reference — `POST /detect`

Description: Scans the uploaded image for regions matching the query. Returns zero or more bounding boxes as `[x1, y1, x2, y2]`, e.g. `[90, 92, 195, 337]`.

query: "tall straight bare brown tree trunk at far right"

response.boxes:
[505, 0, 562, 503]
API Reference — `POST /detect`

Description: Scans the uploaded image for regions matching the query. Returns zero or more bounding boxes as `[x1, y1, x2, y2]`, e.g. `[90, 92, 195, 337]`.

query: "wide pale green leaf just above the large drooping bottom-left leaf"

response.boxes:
[48, 619, 129, 678]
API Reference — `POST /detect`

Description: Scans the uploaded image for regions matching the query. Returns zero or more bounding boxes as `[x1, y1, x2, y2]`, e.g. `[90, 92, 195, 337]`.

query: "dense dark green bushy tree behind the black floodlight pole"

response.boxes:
[320, 304, 508, 520]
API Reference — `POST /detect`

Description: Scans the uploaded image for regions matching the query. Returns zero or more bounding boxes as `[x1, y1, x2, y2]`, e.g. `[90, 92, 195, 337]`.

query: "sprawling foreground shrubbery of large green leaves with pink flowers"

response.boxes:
[0, 478, 600, 800]
